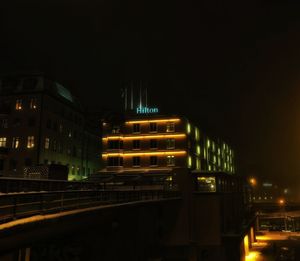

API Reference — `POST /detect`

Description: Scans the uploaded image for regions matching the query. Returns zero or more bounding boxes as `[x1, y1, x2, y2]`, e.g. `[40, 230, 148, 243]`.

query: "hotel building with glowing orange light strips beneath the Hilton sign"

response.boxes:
[102, 114, 235, 174]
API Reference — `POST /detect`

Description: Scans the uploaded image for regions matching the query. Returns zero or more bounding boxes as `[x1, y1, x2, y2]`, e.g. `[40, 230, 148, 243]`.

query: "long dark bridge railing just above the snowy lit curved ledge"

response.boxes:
[0, 190, 180, 223]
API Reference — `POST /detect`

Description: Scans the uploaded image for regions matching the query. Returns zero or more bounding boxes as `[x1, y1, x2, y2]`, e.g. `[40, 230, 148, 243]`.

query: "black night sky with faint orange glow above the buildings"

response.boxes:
[0, 0, 300, 184]
